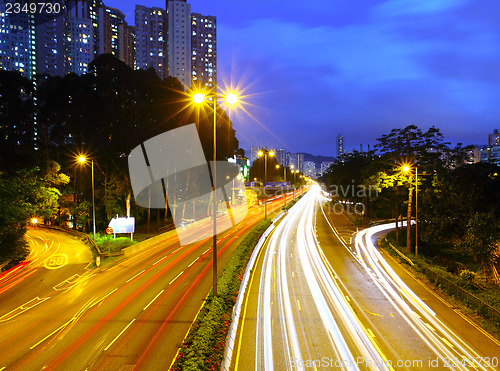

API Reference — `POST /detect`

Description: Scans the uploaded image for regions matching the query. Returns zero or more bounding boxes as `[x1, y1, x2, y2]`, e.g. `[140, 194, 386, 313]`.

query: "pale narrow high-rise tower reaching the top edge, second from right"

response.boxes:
[166, 0, 192, 87]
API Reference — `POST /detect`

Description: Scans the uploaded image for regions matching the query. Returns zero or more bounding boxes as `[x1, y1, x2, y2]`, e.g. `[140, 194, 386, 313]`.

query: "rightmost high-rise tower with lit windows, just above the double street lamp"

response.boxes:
[191, 13, 217, 89]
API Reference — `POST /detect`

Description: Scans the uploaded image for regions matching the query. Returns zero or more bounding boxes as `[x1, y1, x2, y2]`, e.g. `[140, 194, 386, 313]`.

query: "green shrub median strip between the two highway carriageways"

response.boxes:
[172, 220, 270, 371]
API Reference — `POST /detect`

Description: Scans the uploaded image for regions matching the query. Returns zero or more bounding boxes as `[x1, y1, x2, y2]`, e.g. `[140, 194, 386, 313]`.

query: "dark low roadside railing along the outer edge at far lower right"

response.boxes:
[425, 267, 500, 325]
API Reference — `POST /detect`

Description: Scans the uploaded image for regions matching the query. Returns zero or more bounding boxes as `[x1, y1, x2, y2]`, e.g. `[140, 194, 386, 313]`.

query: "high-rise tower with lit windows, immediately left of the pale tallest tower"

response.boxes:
[135, 5, 167, 78]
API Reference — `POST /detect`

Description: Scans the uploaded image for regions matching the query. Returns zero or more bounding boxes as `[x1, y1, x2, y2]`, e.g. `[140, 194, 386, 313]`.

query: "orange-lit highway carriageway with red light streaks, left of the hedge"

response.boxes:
[0, 193, 300, 370]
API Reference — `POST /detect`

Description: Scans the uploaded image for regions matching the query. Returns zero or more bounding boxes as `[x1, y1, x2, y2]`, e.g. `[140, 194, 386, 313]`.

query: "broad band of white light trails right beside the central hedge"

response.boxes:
[255, 186, 391, 371]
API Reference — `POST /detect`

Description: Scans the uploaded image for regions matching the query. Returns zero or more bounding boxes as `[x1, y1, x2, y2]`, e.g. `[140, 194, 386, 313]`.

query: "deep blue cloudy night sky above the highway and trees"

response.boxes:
[104, 0, 500, 155]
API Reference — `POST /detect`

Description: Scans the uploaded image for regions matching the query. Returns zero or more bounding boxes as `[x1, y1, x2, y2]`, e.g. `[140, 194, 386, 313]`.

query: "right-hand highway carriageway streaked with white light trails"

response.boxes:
[231, 186, 500, 370]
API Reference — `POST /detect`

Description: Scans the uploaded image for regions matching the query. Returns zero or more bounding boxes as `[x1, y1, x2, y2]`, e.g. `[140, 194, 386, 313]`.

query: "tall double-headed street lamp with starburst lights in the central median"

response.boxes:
[192, 90, 238, 297]
